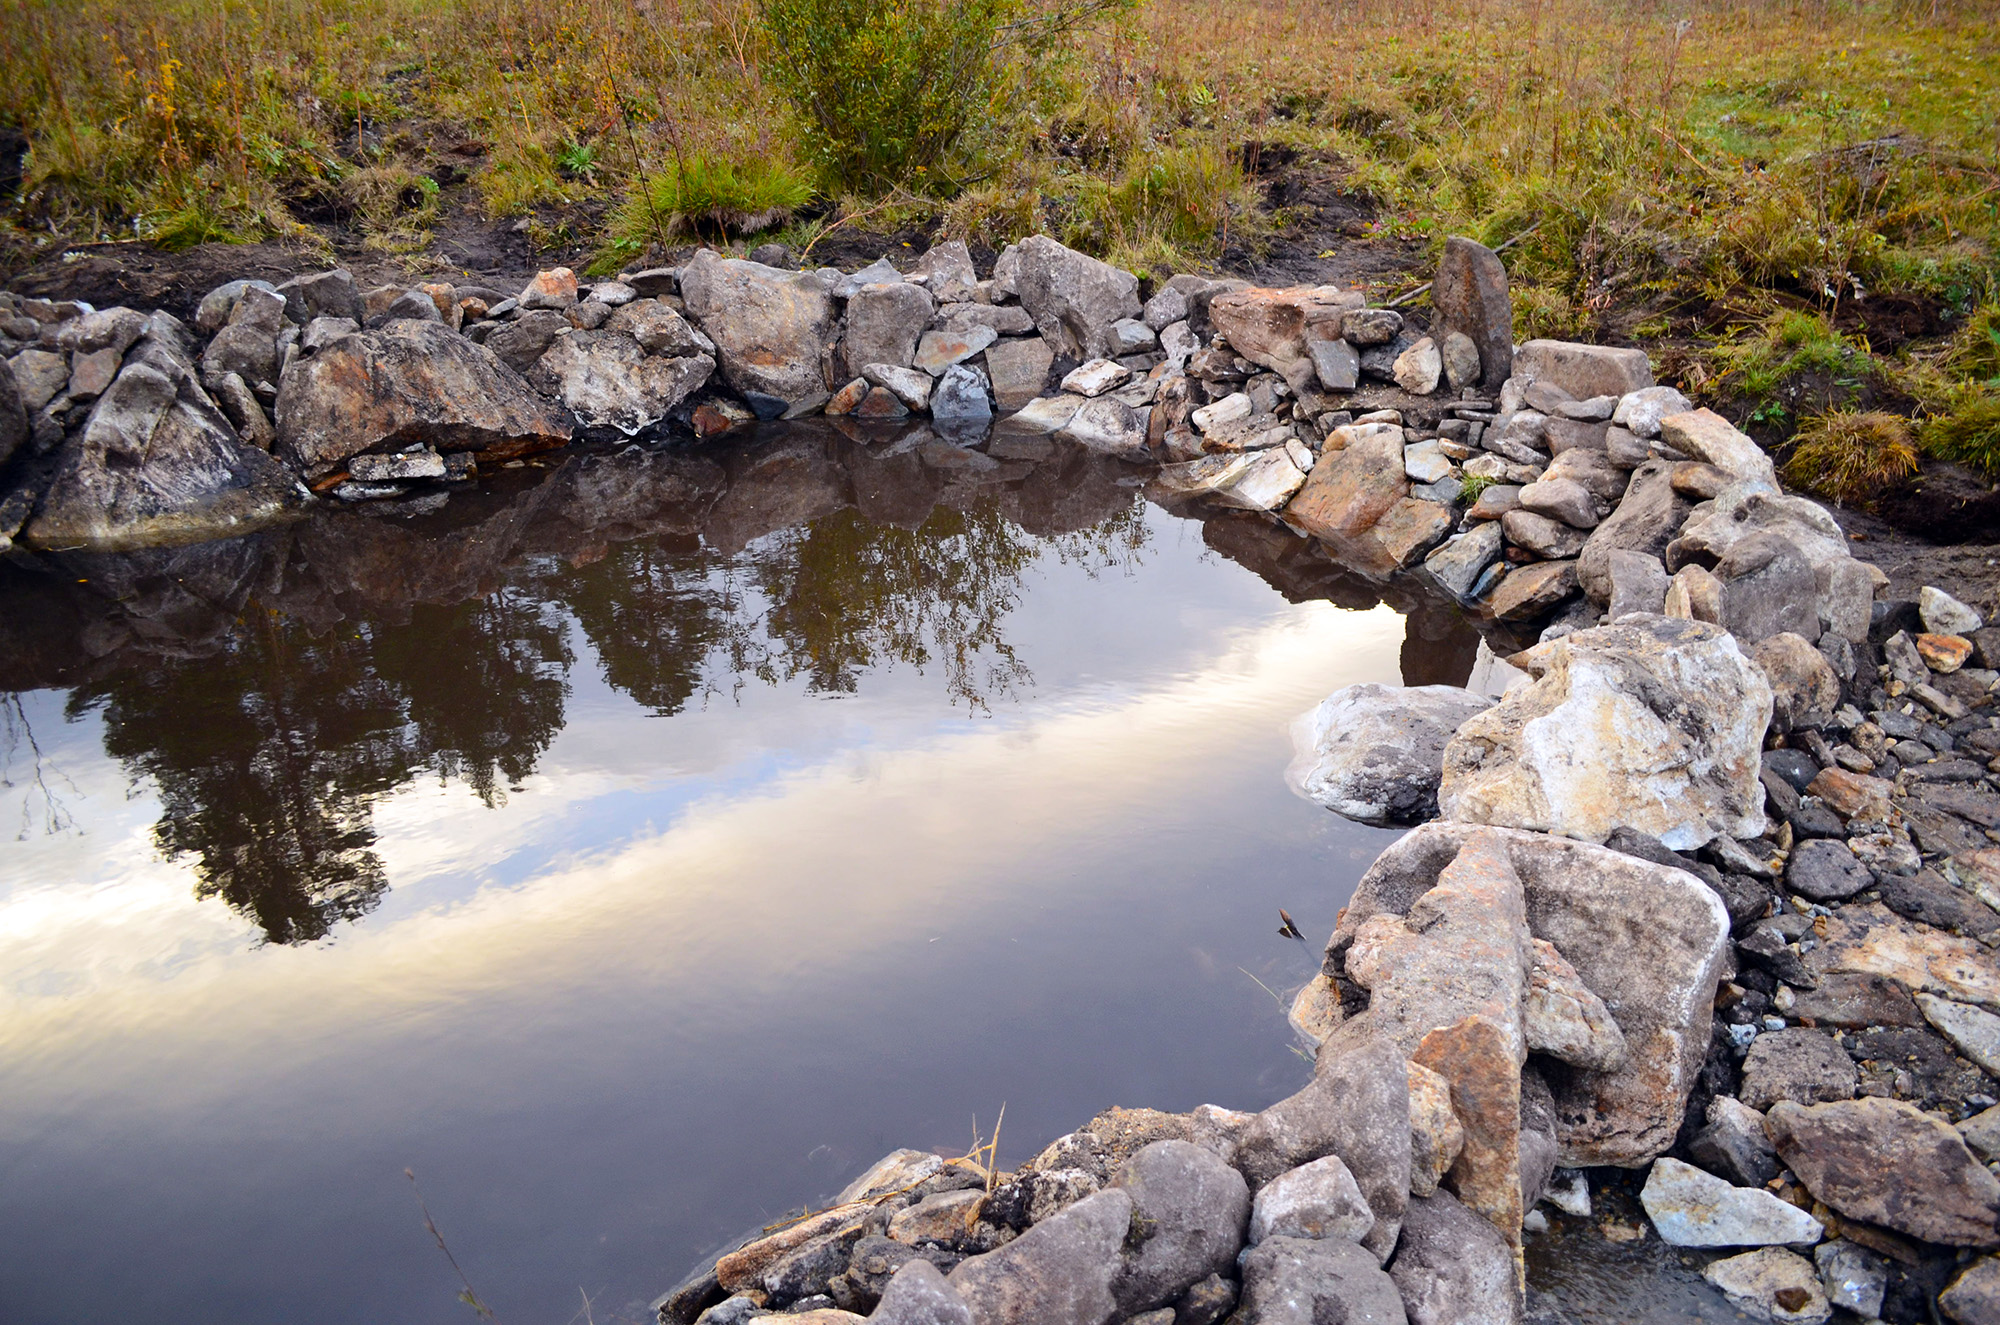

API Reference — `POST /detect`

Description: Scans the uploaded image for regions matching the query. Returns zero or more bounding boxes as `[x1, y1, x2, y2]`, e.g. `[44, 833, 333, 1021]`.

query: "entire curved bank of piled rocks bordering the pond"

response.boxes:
[0, 238, 2000, 1325]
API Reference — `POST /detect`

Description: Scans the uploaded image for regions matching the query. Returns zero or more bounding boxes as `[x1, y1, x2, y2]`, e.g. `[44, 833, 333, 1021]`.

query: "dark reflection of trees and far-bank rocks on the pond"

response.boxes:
[0, 424, 1144, 943]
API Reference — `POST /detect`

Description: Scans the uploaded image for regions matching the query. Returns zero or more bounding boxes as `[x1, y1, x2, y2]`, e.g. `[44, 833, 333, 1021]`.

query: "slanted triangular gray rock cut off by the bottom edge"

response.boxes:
[946, 1187, 1132, 1325]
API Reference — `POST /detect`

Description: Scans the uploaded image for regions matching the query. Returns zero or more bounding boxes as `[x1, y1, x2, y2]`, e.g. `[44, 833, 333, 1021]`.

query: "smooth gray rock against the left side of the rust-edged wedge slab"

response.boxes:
[1232, 1041, 1410, 1259]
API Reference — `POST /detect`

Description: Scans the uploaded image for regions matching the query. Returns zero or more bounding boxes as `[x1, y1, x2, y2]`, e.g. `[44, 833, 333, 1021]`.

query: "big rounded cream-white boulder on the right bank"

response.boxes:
[1438, 616, 1772, 851]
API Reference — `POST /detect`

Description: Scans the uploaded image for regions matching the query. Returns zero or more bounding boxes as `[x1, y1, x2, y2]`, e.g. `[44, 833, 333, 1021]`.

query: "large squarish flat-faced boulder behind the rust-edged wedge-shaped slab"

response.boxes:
[1322, 823, 1730, 1167]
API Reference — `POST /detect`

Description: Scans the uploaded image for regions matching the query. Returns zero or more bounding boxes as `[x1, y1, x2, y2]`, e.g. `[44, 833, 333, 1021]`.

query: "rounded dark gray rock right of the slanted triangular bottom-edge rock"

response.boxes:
[1112, 1141, 1250, 1313]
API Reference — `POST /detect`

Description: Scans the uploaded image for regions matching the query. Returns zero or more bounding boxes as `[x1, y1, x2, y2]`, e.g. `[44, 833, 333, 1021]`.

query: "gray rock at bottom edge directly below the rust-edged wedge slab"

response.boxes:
[1388, 1191, 1522, 1325]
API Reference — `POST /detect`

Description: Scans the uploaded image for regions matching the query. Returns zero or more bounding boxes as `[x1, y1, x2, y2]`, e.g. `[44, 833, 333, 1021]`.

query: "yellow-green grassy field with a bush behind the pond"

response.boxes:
[0, 0, 2000, 492]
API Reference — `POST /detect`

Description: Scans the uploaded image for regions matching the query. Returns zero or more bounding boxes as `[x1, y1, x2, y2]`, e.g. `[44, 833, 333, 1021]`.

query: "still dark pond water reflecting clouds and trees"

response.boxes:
[0, 428, 1728, 1323]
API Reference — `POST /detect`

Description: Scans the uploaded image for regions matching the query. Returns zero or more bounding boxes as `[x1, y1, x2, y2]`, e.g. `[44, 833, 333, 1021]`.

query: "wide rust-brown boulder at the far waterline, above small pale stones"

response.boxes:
[276, 318, 574, 478]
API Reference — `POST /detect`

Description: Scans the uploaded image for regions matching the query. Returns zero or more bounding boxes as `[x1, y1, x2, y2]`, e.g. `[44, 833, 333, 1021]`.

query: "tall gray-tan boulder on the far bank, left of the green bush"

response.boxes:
[680, 248, 834, 418]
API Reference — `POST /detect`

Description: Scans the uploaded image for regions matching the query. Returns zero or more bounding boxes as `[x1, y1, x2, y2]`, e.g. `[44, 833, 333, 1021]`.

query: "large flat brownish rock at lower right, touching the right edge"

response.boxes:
[1768, 1097, 2000, 1247]
